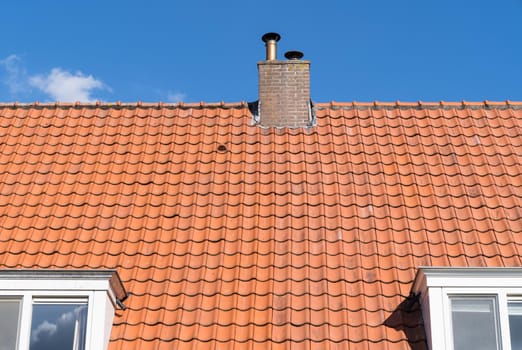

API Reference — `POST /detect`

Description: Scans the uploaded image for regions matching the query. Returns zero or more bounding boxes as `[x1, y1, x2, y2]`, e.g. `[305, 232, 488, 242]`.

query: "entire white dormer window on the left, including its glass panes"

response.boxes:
[0, 270, 126, 350]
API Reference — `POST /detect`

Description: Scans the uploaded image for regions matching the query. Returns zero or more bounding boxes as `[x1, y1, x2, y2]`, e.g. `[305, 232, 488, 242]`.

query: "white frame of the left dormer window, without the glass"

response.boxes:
[0, 270, 127, 350]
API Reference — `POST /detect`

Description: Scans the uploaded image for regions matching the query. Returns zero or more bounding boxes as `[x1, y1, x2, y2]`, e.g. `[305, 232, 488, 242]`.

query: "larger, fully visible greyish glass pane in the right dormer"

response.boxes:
[451, 297, 499, 350]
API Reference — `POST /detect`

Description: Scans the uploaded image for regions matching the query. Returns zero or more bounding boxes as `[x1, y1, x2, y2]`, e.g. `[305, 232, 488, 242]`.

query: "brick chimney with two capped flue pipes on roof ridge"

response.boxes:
[256, 33, 313, 128]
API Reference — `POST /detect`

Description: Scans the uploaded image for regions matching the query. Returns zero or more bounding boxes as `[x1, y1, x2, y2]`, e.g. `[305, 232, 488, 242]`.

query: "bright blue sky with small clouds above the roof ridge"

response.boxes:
[0, 0, 522, 102]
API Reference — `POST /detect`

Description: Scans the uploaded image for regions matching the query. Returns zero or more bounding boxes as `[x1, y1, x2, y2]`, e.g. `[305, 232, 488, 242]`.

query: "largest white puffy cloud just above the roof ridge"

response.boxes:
[29, 68, 108, 102]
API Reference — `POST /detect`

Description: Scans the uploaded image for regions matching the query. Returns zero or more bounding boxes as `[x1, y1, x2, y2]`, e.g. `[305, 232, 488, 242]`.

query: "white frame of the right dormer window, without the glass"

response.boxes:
[412, 267, 522, 350]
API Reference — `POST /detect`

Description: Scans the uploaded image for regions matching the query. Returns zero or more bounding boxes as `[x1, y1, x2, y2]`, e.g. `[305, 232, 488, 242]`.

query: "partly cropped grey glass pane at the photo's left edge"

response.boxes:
[0, 299, 21, 350]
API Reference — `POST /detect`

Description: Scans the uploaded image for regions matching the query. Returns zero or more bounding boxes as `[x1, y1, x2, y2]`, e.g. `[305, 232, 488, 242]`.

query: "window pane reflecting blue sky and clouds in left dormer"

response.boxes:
[30, 303, 87, 350]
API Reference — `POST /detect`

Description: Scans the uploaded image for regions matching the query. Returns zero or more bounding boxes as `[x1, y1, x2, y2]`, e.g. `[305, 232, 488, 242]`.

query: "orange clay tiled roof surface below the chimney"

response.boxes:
[0, 101, 522, 350]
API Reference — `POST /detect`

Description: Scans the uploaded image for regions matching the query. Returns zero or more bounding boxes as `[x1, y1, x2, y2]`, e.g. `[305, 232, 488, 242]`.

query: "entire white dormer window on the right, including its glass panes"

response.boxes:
[412, 267, 522, 350]
